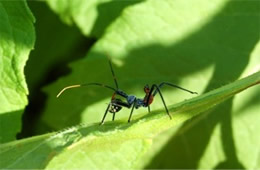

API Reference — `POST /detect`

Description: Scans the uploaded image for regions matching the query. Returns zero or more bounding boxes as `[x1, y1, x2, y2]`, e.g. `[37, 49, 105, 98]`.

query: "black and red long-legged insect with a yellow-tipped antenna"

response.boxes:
[57, 58, 197, 125]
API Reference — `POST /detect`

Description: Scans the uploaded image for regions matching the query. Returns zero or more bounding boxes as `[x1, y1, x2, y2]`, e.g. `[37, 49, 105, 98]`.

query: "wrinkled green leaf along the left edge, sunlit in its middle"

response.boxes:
[0, 1, 35, 143]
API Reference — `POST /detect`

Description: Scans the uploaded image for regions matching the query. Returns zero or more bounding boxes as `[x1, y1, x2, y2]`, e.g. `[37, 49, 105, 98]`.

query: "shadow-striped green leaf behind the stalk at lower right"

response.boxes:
[146, 43, 260, 169]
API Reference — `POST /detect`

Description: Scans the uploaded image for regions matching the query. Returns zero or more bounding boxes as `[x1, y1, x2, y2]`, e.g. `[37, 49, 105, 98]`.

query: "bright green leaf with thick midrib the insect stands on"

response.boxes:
[0, 72, 260, 169]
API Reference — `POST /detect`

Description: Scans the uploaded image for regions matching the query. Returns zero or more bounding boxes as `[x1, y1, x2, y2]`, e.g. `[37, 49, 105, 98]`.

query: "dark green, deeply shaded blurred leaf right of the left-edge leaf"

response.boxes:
[25, 1, 83, 95]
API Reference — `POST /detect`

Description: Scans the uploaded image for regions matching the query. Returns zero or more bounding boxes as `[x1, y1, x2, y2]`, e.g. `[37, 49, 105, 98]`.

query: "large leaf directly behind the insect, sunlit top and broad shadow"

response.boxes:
[41, 0, 259, 129]
